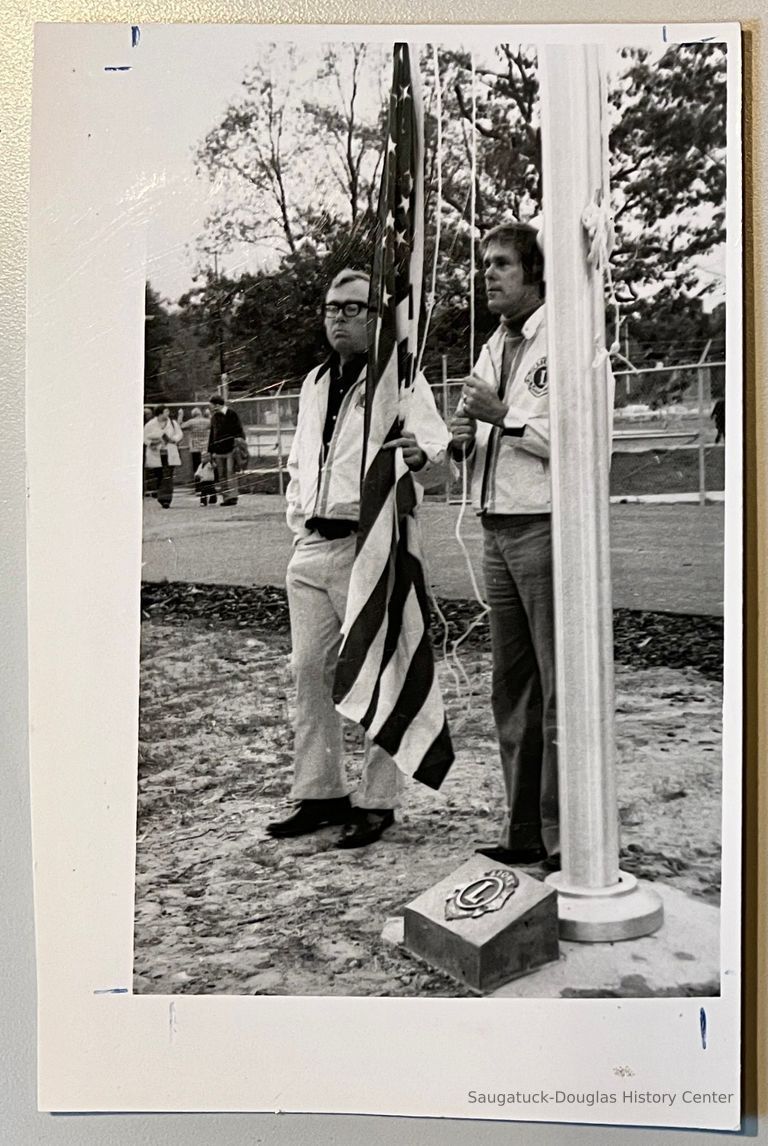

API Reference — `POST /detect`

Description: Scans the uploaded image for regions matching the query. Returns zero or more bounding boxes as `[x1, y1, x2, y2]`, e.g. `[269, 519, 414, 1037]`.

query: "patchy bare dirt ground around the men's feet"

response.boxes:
[134, 619, 721, 996]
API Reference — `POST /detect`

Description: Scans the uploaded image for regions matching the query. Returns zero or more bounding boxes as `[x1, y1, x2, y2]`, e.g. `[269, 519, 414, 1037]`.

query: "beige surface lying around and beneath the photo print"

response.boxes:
[0, 0, 768, 1144]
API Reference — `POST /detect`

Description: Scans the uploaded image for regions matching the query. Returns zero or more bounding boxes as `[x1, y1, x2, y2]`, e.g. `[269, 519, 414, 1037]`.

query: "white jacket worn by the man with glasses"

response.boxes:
[285, 361, 450, 539]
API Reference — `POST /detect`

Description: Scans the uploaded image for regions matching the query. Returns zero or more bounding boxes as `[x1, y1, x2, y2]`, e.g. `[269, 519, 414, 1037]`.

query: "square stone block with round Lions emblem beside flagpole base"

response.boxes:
[403, 856, 559, 992]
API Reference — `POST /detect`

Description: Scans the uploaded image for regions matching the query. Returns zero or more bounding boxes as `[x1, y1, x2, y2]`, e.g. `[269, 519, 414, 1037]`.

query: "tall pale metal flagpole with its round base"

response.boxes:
[540, 45, 663, 942]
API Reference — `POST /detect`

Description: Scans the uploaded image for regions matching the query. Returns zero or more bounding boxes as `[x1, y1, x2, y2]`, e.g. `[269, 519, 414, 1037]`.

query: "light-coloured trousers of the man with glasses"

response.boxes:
[285, 534, 403, 808]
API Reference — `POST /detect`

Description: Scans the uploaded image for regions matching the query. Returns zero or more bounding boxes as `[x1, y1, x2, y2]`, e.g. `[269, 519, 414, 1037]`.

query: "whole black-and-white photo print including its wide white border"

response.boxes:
[30, 24, 742, 1128]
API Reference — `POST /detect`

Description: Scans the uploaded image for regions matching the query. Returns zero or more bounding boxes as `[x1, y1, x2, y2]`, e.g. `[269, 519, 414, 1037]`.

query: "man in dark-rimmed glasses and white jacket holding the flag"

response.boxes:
[267, 270, 450, 848]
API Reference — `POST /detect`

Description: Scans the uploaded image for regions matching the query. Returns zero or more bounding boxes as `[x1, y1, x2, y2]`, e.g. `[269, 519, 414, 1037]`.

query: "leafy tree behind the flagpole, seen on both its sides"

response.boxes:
[426, 44, 726, 378]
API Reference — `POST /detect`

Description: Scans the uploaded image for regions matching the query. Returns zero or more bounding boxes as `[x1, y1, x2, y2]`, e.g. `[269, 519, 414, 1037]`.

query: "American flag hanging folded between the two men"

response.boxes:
[334, 44, 454, 788]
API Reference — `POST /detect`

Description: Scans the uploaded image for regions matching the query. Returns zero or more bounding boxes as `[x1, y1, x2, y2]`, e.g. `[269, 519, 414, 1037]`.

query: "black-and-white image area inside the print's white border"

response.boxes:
[134, 26, 739, 998]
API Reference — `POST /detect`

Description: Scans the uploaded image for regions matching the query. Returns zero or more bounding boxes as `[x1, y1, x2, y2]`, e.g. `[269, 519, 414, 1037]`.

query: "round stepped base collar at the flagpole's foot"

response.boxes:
[546, 871, 664, 943]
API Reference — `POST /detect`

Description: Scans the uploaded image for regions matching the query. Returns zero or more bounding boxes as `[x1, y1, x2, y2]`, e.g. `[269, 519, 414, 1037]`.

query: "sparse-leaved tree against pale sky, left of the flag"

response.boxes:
[196, 44, 392, 262]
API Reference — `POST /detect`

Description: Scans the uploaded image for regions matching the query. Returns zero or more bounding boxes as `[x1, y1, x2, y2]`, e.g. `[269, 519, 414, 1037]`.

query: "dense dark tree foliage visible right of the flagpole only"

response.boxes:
[610, 44, 726, 334]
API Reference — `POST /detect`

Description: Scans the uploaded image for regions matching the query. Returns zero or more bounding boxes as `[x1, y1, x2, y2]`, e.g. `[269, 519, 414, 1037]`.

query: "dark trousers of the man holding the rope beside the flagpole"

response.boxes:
[483, 513, 559, 855]
